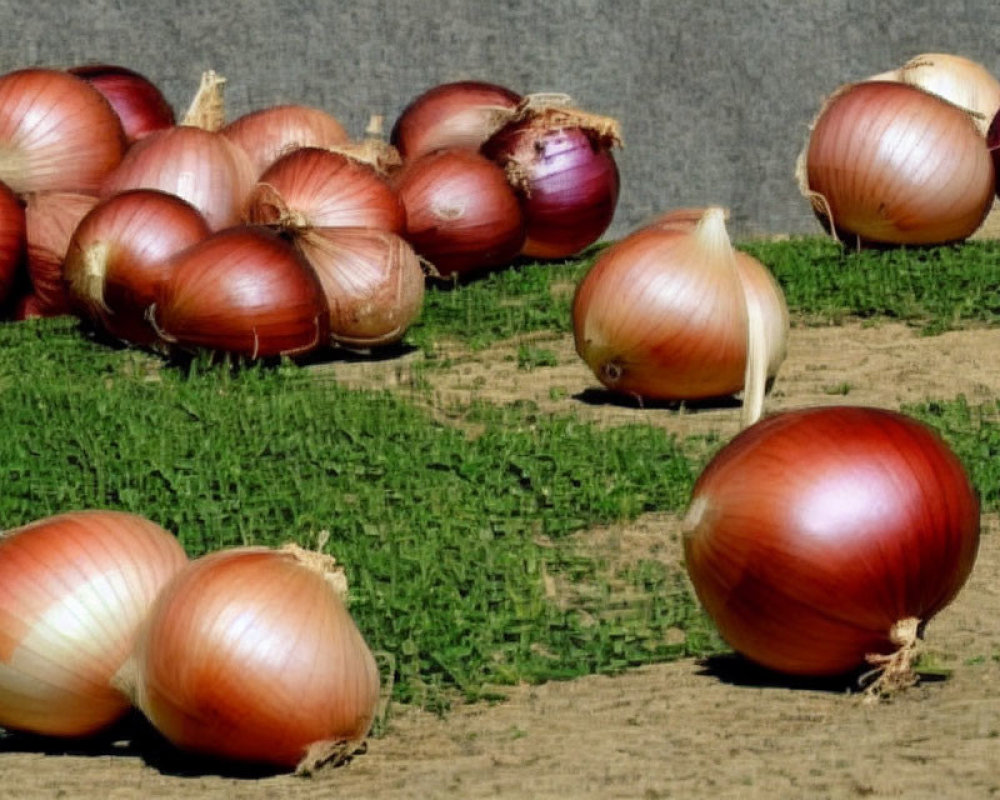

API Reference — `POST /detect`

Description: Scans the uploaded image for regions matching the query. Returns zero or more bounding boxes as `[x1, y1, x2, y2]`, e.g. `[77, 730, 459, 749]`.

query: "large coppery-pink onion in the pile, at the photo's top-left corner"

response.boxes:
[0, 68, 125, 194]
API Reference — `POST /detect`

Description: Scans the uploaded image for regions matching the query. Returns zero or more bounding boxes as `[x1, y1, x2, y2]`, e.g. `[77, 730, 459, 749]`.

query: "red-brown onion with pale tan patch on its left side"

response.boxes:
[63, 189, 211, 345]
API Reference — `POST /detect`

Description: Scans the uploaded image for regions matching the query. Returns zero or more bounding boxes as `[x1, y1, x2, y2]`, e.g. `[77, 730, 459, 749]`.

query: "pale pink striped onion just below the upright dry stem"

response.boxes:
[101, 125, 255, 231]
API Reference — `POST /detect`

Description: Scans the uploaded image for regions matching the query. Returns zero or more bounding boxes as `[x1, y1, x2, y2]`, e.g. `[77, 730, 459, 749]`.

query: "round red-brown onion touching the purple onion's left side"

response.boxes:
[394, 149, 525, 276]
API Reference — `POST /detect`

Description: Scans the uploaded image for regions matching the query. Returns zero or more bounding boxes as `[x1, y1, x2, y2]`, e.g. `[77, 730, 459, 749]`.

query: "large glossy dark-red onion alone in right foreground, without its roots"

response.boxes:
[684, 406, 979, 676]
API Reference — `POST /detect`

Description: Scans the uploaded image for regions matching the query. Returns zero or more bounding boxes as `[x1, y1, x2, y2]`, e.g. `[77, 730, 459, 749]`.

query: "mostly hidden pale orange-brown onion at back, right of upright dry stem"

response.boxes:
[220, 105, 350, 176]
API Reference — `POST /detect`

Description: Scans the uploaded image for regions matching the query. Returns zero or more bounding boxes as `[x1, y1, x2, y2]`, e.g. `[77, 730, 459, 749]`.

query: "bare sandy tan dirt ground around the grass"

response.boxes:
[0, 323, 1000, 800]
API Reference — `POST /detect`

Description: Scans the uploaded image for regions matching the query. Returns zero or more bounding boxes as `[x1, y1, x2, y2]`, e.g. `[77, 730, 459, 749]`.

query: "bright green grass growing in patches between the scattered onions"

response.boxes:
[0, 239, 1000, 708]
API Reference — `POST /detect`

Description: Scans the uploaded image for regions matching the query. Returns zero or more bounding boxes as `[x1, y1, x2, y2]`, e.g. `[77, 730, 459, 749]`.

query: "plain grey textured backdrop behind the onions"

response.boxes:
[7, 0, 1000, 241]
